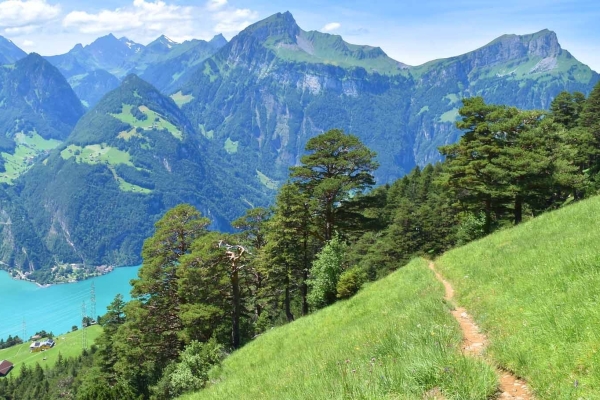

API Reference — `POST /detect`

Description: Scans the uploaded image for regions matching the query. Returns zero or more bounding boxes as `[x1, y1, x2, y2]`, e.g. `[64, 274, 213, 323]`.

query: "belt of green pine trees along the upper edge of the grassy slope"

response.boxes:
[0, 85, 600, 399]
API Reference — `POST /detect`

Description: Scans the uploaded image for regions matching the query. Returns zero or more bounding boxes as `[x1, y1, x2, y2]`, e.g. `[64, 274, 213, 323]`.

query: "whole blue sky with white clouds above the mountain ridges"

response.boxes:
[0, 0, 600, 71]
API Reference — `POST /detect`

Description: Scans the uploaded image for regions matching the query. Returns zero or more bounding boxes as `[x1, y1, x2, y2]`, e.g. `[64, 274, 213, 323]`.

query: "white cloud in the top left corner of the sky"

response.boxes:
[0, 0, 60, 35]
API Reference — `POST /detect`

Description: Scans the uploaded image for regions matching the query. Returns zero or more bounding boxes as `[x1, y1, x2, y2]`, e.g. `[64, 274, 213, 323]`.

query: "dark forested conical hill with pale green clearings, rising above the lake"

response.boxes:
[5, 75, 262, 279]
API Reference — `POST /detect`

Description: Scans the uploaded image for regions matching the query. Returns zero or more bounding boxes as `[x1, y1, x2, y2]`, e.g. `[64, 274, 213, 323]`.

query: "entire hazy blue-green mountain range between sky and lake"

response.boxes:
[0, 13, 600, 278]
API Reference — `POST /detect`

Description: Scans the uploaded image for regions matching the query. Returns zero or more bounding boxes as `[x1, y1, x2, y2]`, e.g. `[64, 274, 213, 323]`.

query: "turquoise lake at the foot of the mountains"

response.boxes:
[0, 266, 139, 340]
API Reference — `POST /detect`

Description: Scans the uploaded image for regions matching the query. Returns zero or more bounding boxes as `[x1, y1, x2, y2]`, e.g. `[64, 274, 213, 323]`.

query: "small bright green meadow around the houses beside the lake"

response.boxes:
[0, 325, 102, 376]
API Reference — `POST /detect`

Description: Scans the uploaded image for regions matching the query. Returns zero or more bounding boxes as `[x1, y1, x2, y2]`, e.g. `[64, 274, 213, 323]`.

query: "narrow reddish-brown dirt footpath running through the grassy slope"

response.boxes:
[429, 262, 534, 400]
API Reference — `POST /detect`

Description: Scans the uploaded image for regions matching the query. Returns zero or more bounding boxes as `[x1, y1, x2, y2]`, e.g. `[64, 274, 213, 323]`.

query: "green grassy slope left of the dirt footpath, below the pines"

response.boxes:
[186, 260, 497, 399]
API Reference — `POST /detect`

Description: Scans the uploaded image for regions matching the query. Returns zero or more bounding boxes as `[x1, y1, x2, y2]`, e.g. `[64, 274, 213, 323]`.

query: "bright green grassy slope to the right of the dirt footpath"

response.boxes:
[437, 197, 600, 399]
